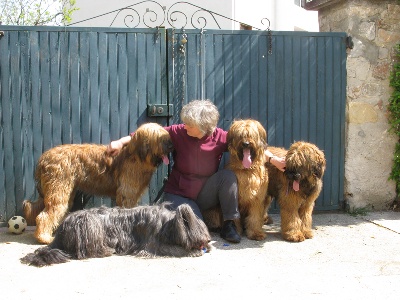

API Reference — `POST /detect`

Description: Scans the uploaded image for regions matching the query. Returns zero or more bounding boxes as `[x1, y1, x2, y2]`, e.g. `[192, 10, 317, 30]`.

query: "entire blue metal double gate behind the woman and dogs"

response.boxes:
[0, 26, 346, 221]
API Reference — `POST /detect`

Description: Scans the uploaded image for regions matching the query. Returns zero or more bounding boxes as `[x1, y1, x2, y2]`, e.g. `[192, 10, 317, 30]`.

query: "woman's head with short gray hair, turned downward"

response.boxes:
[181, 100, 219, 135]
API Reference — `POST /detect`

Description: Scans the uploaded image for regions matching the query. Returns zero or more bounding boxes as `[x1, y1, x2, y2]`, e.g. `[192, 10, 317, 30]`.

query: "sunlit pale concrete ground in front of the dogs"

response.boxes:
[0, 211, 400, 300]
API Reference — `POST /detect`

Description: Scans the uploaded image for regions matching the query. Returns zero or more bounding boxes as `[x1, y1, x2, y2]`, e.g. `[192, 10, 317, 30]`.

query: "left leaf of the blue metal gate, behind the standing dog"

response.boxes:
[0, 26, 167, 221]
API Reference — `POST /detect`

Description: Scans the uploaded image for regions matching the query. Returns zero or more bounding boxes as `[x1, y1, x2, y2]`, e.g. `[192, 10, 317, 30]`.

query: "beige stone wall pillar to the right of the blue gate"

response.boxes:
[317, 0, 400, 209]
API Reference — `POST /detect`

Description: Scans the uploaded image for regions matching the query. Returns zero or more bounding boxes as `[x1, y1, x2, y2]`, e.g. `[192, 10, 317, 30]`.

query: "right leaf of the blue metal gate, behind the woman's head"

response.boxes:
[168, 30, 347, 210]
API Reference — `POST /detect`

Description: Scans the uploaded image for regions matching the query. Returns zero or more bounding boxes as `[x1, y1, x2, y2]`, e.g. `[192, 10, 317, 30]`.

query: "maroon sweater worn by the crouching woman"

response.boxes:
[161, 124, 228, 199]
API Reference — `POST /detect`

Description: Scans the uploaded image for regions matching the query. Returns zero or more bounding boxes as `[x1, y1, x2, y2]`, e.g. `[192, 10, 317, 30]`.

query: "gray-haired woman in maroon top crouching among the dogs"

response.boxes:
[108, 100, 285, 243]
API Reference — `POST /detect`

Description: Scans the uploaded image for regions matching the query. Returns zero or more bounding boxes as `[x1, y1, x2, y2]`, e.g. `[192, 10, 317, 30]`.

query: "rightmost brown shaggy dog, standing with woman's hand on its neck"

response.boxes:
[265, 142, 326, 242]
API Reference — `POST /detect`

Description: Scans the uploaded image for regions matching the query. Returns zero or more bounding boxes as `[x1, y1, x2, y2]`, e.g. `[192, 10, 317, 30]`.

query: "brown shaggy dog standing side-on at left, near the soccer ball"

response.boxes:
[23, 123, 172, 244]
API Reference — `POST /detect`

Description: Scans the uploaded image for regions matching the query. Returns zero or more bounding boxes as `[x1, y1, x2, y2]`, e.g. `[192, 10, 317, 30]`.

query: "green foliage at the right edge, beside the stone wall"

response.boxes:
[388, 44, 400, 194]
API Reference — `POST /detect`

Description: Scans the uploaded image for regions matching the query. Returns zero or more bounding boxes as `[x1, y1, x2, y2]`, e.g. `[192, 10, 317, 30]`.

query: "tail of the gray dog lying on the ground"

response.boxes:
[20, 246, 71, 267]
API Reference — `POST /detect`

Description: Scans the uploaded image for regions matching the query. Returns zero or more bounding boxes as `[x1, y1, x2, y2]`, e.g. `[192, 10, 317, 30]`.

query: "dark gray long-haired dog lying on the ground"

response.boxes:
[21, 203, 211, 267]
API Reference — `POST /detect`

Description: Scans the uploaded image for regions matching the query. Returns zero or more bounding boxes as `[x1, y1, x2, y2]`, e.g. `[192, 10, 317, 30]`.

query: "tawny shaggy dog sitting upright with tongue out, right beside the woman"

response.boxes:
[203, 119, 268, 240]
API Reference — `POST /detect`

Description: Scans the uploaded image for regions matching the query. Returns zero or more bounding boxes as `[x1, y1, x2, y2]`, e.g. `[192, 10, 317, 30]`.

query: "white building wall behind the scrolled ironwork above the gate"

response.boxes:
[73, 0, 319, 31]
